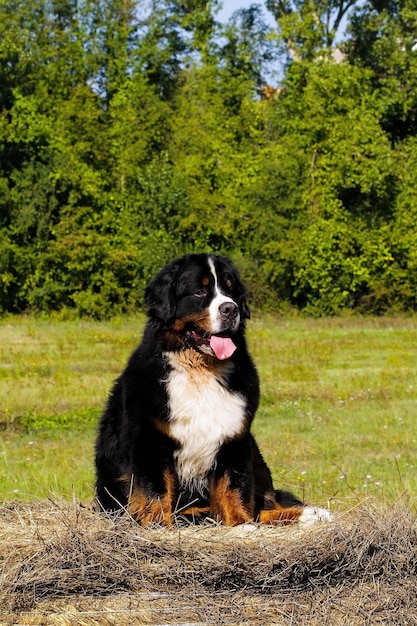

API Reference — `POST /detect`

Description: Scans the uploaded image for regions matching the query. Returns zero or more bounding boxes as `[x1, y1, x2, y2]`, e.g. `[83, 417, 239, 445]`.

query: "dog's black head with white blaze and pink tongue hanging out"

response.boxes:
[145, 254, 250, 360]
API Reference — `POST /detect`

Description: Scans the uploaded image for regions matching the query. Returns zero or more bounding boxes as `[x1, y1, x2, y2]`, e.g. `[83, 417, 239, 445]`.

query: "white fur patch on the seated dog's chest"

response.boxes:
[166, 354, 245, 491]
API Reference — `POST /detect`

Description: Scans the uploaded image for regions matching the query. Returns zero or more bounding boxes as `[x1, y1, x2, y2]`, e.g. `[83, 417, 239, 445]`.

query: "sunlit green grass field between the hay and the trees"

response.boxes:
[0, 316, 417, 510]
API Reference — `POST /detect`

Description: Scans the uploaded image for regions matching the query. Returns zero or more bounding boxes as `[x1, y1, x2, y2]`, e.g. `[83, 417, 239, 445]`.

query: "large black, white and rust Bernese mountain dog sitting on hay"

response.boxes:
[95, 254, 330, 526]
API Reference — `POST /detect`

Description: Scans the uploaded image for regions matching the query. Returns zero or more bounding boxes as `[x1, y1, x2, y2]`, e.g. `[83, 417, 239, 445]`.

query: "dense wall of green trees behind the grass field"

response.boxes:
[0, 0, 417, 317]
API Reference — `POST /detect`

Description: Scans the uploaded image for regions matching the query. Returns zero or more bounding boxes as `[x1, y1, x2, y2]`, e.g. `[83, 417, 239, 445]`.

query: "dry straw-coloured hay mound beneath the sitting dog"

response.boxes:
[0, 501, 417, 626]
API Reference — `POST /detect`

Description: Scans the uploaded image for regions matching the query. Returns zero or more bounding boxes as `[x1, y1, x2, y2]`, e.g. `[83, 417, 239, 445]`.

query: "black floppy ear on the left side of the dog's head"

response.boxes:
[145, 259, 180, 322]
